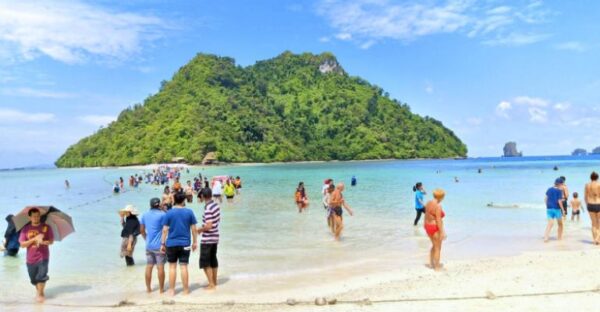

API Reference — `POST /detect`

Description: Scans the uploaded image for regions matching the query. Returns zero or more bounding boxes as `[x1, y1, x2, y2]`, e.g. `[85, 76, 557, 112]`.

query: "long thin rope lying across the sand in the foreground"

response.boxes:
[0, 286, 600, 308]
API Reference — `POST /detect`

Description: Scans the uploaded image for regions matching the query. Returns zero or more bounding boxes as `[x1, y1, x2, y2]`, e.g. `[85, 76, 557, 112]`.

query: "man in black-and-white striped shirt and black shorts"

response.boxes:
[198, 188, 221, 290]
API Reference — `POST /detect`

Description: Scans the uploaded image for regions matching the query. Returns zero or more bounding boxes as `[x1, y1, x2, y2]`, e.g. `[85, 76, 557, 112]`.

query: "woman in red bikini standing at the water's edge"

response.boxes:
[425, 189, 446, 271]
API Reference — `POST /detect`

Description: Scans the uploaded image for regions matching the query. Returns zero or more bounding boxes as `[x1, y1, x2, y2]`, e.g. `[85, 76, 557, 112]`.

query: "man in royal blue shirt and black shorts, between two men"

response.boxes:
[160, 192, 198, 296]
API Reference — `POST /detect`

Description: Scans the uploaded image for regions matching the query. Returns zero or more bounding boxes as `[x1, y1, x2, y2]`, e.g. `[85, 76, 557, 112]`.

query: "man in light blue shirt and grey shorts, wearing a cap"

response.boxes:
[140, 198, 167, 294]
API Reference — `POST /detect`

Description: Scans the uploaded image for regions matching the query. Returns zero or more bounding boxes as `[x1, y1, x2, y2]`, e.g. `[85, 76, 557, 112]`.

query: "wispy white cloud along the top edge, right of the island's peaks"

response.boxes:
[317, 0, 550, 45]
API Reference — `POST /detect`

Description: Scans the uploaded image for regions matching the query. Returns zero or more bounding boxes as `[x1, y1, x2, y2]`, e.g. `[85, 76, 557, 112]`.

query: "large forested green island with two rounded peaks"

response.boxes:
[56, 52, 467, 167]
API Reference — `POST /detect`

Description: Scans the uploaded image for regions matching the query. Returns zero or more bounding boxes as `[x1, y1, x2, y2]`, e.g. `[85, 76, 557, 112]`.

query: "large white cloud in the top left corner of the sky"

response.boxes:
[0, 0, 167, 64]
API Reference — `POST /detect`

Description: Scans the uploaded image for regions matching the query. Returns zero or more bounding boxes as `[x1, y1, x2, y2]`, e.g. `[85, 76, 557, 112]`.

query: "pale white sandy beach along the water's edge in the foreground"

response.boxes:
[3, 249, 600, 312]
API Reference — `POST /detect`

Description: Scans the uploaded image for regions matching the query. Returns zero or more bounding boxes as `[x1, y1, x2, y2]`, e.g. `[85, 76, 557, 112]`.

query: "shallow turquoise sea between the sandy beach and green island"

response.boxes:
[0, 156, 600, 304]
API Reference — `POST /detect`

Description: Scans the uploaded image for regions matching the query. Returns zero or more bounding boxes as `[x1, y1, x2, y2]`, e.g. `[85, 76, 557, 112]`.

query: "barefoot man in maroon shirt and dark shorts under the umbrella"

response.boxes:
[19, 208, 54, 302]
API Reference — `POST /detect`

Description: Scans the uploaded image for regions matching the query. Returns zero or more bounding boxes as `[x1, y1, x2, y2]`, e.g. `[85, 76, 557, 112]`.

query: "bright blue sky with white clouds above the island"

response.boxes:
[0, 0, 600, 168]
